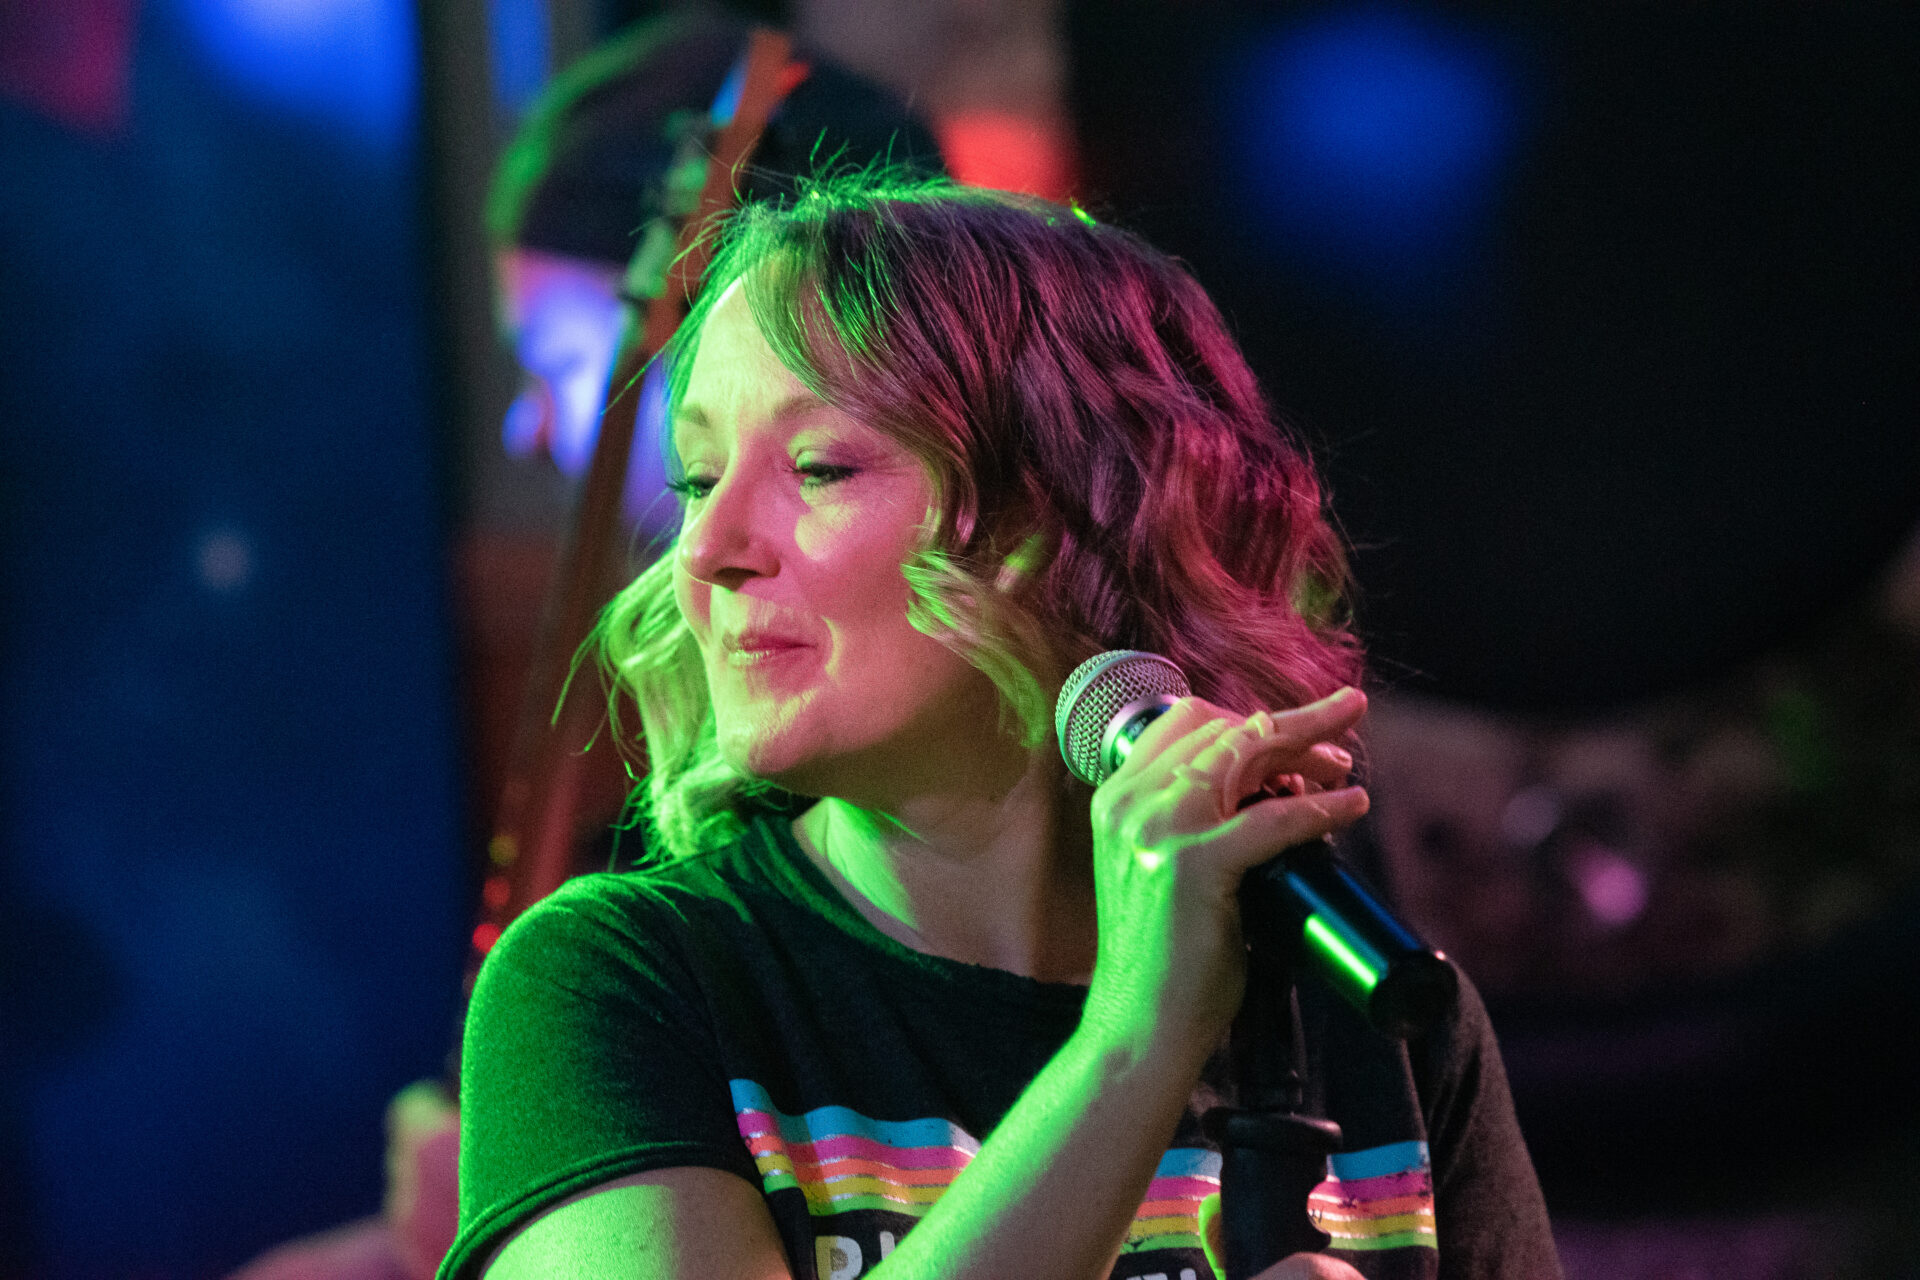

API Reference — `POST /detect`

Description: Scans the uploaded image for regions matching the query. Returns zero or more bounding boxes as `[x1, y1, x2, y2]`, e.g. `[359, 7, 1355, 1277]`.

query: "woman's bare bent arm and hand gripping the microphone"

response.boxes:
[476, 695, 1365, 1280]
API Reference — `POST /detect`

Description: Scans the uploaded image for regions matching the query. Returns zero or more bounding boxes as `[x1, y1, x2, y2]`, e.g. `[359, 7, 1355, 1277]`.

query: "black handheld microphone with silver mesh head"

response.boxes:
[1054, 649, 1459, 1040]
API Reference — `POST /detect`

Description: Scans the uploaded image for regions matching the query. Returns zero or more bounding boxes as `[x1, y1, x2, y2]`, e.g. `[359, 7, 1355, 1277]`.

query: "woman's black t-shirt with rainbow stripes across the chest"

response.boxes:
[440, 818, 1559, 1280]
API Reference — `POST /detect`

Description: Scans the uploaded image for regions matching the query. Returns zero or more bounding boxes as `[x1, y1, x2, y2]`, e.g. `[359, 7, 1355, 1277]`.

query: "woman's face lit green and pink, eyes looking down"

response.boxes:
[674, 284, 996, 804]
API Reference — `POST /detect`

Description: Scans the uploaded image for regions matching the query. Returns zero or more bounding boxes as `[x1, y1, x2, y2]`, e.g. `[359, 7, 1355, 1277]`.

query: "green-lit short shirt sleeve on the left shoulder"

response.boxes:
[440, 875, 758, 1280]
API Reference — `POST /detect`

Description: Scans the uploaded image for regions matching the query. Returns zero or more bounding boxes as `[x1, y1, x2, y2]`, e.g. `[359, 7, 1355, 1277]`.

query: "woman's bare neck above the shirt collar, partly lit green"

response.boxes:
[793, 750, 1096, 983]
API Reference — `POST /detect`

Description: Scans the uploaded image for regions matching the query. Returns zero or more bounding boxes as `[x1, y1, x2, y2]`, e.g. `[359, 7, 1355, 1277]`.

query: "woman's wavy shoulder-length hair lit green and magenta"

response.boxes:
[597, 171, 1361, 858]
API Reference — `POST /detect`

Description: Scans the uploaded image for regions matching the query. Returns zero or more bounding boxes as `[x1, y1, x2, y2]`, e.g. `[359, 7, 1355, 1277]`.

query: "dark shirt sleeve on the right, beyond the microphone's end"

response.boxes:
[1407, 977, 1561, 1280]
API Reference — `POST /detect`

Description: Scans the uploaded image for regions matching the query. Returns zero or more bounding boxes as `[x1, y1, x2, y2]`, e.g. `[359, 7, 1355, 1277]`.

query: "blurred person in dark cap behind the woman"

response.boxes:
[230, 6, 943, 1280]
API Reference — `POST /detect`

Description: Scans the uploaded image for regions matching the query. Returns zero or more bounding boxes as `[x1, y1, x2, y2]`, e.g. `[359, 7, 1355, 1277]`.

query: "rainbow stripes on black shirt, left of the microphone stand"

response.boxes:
[732, 1080, 1219, 1253]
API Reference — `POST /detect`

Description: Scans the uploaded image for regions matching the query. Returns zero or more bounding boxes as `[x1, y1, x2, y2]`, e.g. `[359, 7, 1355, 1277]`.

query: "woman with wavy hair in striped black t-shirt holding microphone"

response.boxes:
[442, 178, 1557, 1280]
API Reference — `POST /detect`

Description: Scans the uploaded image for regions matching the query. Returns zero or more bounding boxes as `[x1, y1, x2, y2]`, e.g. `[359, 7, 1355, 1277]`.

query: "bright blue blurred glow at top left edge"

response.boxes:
[175, 0, 415, 152]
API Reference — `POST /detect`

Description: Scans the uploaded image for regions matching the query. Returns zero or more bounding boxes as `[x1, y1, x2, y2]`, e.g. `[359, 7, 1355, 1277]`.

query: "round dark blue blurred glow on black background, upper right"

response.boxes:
[1238, 6, 1515, 265]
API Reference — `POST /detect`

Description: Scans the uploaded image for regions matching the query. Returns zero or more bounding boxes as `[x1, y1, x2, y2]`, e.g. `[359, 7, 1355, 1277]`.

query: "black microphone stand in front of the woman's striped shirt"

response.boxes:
[1202, 887, 1340, 1280]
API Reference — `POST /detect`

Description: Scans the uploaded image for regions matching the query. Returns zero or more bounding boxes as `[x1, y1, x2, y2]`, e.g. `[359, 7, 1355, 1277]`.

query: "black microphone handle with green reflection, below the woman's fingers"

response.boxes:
[1240, 839, 1459, 1040]
